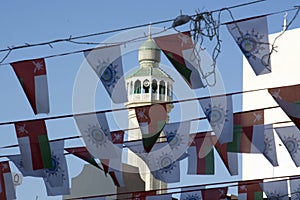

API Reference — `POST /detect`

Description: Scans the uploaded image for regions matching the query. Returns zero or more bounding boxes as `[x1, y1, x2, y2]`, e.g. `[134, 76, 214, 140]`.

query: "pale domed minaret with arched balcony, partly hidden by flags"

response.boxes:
[126, 28, 174, 190]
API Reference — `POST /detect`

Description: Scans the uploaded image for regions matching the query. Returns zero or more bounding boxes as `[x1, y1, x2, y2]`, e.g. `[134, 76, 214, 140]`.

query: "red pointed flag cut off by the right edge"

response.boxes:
[269, 84, 300, 129]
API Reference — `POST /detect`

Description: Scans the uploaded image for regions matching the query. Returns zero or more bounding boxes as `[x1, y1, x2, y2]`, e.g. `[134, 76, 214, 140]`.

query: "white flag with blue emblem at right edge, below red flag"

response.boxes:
[275, 126, 300, 167]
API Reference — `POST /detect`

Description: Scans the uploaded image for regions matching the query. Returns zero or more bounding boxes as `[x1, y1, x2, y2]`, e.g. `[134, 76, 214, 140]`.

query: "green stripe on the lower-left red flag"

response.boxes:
[38, 135, 53, 168]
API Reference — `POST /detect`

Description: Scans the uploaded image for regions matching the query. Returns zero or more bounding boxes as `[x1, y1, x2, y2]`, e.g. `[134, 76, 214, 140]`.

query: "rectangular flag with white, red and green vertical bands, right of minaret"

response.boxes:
[187, 132, 215, 175]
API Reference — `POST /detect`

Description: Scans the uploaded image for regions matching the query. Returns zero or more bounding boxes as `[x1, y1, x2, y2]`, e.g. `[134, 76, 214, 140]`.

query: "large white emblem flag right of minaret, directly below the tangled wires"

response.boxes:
[199, 96, 233, 144]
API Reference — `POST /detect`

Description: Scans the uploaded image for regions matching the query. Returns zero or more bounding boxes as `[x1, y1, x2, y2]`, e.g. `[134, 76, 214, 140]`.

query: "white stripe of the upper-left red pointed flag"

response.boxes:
[34, 75, 49, 113]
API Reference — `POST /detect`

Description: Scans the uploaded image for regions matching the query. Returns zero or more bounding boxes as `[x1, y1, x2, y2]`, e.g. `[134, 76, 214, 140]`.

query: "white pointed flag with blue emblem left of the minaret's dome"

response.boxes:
[83, 45, 128, 103]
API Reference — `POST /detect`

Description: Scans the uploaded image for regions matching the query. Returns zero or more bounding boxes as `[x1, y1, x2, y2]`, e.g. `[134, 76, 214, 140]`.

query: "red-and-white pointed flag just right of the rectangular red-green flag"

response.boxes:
[212, 137, 239, 176]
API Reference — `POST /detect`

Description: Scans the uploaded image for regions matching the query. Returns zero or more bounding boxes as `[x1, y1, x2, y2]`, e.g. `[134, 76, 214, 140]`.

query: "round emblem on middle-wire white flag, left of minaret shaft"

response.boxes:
[84, 124, 108, 147]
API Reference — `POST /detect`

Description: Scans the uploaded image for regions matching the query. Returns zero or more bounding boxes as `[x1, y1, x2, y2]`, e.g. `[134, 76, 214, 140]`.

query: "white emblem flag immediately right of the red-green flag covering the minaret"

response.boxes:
[163, 121, 190, 160]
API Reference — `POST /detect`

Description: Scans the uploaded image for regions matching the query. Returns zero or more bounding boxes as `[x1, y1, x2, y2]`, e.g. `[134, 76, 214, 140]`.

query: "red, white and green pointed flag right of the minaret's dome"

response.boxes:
[154, 31, 204, 89]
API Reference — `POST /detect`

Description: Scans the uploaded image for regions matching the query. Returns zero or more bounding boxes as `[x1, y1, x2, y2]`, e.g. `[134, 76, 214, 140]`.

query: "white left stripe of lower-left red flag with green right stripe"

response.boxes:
[18, 137, 33, 171]
